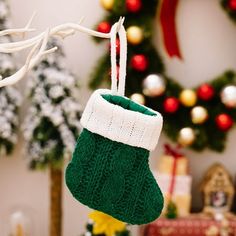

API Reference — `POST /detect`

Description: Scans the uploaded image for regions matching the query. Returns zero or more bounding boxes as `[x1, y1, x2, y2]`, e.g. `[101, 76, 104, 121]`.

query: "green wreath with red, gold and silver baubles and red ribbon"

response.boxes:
[90, 0, 236, 151]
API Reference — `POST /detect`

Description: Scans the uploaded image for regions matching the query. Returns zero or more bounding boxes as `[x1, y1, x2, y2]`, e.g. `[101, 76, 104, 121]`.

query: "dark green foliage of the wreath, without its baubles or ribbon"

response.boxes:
[90, 0, 236, 152]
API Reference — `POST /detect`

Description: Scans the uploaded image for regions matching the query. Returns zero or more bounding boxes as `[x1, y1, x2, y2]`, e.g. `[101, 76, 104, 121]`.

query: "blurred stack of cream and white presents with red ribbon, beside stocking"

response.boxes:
[154, 144, 192, 218]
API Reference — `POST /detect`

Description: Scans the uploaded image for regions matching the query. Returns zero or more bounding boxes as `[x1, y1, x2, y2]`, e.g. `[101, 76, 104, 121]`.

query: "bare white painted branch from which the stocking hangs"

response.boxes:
[0, 15, 124, 87]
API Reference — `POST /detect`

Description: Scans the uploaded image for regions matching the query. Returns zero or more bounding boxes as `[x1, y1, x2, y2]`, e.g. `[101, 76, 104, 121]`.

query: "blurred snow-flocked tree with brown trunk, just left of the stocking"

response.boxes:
[23, 39, 81, 236]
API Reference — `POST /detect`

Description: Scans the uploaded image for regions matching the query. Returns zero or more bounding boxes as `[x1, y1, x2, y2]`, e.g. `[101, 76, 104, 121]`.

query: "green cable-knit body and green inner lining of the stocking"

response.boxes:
[66, 94, 163, 224]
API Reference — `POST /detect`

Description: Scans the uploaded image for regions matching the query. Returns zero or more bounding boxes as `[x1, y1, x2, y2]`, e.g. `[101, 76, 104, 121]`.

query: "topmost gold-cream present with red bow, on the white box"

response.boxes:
[157, 144, 188, 175]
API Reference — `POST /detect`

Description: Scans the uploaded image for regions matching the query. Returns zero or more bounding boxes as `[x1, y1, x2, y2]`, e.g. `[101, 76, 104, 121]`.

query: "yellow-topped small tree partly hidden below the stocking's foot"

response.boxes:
[83, 211, 130, 236]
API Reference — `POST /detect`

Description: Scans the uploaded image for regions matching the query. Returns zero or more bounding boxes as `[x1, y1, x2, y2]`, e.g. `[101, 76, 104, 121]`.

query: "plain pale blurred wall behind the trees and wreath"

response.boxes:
[0, 0, 236, 236]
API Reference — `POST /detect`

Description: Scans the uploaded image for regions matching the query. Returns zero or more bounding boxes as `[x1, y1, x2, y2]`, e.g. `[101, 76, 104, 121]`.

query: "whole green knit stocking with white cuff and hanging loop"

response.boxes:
[66, 23, 163, 224]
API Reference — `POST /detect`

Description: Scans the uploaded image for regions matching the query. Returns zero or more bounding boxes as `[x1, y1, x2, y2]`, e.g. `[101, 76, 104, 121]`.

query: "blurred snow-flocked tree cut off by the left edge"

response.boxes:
[0, 0, 21, 157]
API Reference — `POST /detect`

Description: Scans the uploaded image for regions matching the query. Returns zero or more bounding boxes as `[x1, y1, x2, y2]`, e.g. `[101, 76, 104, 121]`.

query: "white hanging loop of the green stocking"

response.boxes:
[111, 23, 127, 96]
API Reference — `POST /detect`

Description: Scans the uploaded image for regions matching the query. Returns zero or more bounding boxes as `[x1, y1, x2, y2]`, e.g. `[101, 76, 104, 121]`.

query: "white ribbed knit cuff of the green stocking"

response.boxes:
[81, 89, 163, 150]
